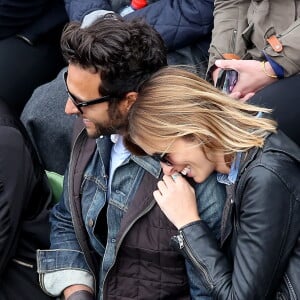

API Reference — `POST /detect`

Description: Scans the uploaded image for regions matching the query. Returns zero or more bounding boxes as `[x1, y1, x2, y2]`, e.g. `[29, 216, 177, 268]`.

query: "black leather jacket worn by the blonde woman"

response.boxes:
[173, 132, 300, 300]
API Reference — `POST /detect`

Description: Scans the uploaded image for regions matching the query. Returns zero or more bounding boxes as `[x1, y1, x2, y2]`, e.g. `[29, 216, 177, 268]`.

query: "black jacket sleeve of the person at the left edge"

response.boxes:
[0, 126, 35, 276]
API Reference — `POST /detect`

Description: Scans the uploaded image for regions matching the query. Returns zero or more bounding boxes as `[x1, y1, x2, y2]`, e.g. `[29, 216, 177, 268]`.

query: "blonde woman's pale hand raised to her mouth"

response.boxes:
[153, 173, 200, 229]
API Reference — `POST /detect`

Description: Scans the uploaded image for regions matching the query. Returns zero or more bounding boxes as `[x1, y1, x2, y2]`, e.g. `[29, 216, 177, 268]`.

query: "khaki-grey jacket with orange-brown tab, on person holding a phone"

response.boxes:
[209, 0, 300, 77]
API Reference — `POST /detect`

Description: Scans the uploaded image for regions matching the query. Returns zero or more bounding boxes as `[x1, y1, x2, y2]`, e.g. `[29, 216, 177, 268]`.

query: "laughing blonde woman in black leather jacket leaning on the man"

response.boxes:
[127, 68, 300, 300]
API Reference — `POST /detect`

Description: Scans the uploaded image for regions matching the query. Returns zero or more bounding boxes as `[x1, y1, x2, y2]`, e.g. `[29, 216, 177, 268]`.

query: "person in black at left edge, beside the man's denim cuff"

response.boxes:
[0, 101, 52, 300]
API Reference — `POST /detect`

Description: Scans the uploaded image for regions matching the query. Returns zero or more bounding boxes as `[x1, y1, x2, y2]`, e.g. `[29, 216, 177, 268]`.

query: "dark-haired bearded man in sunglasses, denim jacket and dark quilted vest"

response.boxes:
[37, 13, 225, 300]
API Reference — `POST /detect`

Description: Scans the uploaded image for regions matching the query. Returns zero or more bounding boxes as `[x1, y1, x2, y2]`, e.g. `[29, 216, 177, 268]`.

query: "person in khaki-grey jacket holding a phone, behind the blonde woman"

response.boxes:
[207, 0, 300, 145]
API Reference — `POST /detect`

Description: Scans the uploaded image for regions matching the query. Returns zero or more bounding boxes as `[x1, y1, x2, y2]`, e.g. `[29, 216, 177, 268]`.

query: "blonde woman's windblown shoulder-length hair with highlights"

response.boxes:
[128, 67, 276, 154]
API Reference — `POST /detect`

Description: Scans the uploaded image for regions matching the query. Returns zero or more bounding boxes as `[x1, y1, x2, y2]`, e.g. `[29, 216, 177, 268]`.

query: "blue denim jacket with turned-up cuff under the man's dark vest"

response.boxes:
[37, 123, 225, 299]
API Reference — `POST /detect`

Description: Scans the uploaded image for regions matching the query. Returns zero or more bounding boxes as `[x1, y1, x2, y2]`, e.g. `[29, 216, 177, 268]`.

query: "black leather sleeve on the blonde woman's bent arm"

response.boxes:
[177, 167, 295, 300]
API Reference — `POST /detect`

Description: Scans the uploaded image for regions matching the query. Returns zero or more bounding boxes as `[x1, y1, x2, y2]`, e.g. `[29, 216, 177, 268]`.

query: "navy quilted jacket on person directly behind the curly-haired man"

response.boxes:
[65, 0, 214, 51]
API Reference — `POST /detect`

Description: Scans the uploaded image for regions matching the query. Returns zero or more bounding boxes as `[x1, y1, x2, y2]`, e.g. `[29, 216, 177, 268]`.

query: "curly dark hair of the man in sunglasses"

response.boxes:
[61, 16, 167, 99]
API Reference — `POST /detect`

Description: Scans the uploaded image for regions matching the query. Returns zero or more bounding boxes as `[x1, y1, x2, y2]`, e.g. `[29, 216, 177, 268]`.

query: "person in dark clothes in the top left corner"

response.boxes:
[0, 0, 68, 117]
